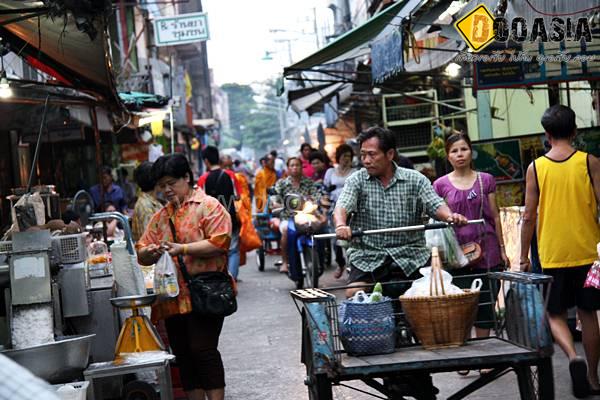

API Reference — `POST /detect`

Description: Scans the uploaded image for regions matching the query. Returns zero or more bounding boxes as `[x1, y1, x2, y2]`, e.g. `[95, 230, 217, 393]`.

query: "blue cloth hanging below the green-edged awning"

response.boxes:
[371, 29, 404, 82]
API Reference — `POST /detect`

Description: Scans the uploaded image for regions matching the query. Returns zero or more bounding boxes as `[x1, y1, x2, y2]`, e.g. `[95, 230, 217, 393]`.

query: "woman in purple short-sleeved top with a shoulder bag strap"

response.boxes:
[433, 132, 508, 366]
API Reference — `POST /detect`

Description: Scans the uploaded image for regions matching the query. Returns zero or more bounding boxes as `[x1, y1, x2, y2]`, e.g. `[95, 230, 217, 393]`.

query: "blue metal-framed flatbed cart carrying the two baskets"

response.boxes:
[291, 222, 554, 400]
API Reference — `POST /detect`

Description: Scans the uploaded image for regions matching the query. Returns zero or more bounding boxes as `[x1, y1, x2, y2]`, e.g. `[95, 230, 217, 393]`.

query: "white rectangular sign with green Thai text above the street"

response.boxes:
[154, 13, 209, 46]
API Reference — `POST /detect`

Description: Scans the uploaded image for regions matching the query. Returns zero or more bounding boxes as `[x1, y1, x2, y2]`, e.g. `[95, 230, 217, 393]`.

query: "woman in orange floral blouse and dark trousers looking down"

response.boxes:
[136, 154, 231, 400]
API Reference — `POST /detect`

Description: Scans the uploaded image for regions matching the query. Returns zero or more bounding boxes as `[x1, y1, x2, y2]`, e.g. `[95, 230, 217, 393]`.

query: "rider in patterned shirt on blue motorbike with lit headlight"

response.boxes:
[273, 157, 319, 273]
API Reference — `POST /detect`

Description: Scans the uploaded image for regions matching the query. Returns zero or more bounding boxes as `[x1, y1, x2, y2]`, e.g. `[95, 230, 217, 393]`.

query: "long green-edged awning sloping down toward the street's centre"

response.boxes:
[283, 0, 423, 76]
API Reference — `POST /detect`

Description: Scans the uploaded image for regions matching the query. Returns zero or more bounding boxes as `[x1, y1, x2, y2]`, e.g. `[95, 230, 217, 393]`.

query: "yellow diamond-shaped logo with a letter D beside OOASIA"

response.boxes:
[454, 4, 495, 52]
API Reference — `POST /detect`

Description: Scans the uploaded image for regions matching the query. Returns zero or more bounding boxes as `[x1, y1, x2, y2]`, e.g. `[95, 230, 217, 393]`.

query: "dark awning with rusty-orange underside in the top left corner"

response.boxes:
[0, 0, 124, 111]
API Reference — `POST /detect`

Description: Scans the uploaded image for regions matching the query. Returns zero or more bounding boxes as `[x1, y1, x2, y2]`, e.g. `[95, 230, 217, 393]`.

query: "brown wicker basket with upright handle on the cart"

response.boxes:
[400, 253, 479, 349]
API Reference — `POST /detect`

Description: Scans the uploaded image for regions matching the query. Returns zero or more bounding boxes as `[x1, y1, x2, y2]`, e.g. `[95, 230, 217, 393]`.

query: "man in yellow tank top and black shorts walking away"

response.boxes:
[521, 105, 600, 398]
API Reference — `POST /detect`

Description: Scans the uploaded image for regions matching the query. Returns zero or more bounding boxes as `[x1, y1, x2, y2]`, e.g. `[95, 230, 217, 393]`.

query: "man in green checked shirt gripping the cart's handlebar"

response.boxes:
[334, 127, 467, 297]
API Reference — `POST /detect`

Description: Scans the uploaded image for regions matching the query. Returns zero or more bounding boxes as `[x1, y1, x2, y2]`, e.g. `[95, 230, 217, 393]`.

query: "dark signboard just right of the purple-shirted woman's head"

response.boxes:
[473, 139, 524, 182]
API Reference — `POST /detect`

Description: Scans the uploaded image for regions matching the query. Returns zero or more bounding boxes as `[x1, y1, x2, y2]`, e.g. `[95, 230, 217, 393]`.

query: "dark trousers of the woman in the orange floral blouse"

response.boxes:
[165, 314, 225, 391]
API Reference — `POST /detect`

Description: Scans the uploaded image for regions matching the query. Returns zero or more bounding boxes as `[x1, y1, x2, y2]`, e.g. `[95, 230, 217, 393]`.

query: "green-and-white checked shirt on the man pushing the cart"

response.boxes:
[336, 167, 444, 276]
